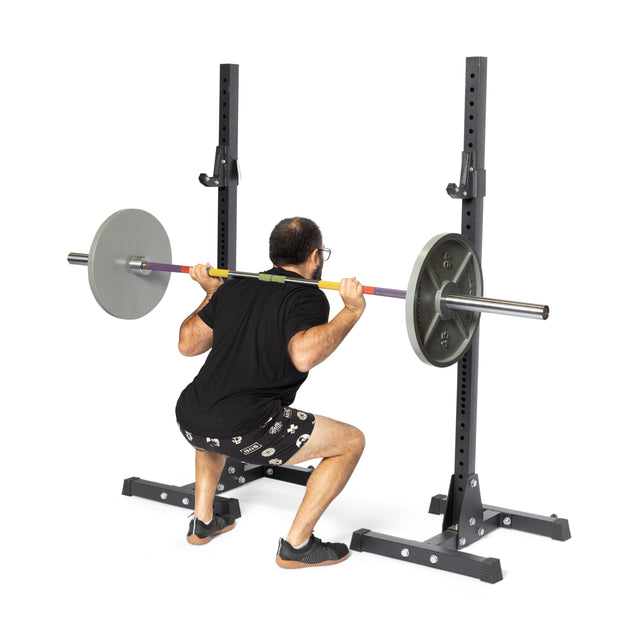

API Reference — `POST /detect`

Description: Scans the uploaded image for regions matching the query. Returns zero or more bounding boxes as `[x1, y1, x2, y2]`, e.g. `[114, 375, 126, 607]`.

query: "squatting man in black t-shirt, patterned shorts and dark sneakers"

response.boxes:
[176, 217, 366, 568]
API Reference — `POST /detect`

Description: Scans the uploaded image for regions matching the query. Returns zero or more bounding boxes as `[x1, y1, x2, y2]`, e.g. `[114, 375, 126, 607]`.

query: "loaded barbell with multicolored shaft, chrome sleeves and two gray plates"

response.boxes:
[67, 209, 549, 367]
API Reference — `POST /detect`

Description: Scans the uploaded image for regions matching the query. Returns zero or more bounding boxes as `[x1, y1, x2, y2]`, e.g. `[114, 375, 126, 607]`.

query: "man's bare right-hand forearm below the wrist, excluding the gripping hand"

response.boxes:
[289, 307, 362, 373]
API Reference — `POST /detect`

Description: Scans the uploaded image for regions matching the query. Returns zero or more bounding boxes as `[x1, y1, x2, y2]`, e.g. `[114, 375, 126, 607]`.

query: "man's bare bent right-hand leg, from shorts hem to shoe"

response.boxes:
[285, 416, 365, 547]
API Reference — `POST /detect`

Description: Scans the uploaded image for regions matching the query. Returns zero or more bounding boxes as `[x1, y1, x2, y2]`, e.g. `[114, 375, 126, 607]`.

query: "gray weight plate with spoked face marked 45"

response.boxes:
[405, 233, 482, 367]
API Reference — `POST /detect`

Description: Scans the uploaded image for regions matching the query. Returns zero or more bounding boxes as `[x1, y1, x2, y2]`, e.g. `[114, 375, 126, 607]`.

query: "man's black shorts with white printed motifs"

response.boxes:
[180, 407, 316, 465]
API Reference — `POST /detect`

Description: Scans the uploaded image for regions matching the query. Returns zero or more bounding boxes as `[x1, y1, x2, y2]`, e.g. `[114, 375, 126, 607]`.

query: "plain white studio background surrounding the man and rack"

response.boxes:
[0, 0, 639, 639]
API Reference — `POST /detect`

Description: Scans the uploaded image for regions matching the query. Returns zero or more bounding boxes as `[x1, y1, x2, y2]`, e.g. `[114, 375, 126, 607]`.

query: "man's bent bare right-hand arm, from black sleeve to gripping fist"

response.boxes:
[289, 278, 366, 373]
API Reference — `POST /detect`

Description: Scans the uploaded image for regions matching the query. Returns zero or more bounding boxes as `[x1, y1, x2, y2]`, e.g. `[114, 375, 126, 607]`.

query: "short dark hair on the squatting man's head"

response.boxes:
[269, 217, 322, 267]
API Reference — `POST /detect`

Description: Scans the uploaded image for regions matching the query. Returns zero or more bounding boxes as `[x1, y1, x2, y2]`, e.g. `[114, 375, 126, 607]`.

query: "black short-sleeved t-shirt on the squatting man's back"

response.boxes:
[176, 267, 329, 438]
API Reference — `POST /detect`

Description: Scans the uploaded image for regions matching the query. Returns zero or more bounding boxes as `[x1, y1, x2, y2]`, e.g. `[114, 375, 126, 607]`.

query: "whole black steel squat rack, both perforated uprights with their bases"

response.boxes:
[122, 57, 571, 583]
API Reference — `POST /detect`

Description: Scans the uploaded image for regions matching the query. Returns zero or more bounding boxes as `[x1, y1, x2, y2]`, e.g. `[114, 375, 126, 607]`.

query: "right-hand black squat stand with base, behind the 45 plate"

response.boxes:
[350, 57, 571, 583]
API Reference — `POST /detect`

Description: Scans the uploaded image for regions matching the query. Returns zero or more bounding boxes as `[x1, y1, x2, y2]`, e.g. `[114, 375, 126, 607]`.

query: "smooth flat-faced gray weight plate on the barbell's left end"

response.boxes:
[87, 209, 171, 319]
